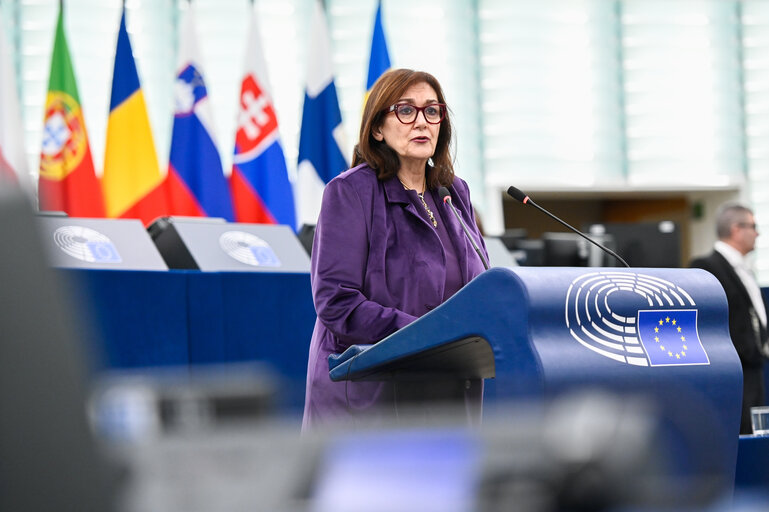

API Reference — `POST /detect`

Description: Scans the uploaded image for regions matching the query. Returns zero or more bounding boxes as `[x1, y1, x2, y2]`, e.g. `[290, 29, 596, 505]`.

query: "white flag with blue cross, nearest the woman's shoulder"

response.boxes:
[297, 1, 348, 224]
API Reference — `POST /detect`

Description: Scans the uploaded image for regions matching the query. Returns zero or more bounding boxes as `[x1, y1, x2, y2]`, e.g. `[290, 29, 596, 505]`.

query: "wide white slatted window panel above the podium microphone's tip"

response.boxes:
[479, 0, 624, 189]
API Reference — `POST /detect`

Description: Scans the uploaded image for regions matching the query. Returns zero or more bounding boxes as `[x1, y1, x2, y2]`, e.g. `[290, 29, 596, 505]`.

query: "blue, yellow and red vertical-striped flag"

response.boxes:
[101, 9, 168, 225]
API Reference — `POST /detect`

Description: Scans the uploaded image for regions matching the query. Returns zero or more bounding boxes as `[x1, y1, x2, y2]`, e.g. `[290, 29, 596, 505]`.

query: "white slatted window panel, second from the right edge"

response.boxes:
[621, 0, 745, 187]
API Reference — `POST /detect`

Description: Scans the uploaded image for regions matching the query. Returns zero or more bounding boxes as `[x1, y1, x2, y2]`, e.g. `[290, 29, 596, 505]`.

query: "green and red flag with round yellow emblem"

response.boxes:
[38, 7, 104, 217]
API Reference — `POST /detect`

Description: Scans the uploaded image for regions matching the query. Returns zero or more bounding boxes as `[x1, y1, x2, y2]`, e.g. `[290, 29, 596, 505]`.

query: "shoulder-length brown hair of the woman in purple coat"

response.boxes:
[352, 69, 454, 189]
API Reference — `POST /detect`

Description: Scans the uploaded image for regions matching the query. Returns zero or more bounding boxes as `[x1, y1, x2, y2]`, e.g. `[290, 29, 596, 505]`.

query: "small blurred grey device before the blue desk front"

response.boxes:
[89, 362, 279, 443]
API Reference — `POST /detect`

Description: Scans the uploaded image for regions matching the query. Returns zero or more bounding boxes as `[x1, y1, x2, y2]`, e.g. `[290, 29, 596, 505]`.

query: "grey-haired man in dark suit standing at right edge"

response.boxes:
[690, 203, 769, 434]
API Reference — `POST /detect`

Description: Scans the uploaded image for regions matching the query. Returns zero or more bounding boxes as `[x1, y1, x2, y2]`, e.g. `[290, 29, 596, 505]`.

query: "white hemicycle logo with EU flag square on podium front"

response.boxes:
[565, 271, 710, 366]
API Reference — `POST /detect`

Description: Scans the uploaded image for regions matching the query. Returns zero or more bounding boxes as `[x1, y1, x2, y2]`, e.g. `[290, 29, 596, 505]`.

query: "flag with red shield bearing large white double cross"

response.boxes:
[230, 4, 297, 229]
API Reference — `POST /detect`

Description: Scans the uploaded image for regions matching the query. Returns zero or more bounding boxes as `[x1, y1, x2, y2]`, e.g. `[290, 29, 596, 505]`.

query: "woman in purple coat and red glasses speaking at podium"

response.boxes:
[303, 69, 486, 429]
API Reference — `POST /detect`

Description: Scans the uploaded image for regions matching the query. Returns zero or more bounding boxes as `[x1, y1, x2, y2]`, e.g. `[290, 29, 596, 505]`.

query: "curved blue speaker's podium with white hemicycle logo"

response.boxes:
[329, 267, 742, 488]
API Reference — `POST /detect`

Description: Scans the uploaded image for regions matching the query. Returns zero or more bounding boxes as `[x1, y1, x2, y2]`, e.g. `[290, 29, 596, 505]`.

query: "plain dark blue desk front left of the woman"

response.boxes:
[59, 269, 315, 409]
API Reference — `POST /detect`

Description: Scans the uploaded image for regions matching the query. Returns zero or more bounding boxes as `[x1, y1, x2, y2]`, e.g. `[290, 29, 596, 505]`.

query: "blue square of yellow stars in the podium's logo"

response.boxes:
[637, 309, 710, 366]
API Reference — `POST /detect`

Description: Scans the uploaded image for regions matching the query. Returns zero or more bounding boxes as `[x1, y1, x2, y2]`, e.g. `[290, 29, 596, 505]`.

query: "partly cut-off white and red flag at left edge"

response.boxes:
[0, 10, 33, 195]
